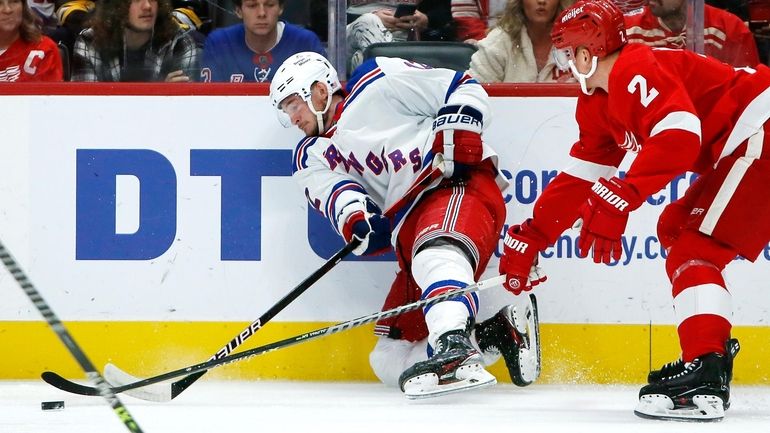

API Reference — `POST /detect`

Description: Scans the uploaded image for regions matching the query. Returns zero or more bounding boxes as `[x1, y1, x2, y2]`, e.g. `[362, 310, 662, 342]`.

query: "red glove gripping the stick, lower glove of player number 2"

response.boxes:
[499, 220, 548, 295]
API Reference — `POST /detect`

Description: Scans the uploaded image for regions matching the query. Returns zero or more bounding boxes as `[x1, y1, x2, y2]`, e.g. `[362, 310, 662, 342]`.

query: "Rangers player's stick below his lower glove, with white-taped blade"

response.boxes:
[104, 240, 361, 402]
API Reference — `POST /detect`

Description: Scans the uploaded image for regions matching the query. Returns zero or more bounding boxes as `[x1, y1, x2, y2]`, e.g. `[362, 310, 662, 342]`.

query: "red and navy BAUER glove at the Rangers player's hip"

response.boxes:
[433, 105, 484, 178]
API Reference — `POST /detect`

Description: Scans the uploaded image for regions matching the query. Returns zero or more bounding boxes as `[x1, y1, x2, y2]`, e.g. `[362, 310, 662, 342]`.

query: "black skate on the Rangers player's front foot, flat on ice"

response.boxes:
[398, 330, 497, 399]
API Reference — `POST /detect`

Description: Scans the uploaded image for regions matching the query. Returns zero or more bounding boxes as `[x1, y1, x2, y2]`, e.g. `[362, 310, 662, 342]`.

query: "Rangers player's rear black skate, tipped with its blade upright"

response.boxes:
[475, 294, 540, 386]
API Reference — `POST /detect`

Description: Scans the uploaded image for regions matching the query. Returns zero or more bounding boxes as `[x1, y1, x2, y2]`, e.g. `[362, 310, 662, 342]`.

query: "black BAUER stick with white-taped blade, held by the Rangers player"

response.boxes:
[93, 155, 444, 402]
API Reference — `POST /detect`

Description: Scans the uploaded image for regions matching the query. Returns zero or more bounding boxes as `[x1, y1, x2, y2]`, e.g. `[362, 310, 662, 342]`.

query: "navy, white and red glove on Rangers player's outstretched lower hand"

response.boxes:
[337, 198, 390, 256]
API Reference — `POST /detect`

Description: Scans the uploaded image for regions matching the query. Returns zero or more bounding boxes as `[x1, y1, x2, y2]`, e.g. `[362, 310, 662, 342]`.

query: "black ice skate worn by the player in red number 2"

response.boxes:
[634, 338, 740, 421]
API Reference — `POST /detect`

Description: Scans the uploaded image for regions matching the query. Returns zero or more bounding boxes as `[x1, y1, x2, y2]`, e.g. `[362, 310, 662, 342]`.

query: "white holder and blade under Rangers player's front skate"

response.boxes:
[404, 364, 497, 400]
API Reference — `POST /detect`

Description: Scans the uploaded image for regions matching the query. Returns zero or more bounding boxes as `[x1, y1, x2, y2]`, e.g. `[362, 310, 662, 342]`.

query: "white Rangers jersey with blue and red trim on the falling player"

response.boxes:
[293, 57, 507, 239]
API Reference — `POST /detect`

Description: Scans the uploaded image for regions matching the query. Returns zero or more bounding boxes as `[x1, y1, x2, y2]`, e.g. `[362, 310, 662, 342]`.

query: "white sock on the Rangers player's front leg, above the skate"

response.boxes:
[412, 245, 478, 347]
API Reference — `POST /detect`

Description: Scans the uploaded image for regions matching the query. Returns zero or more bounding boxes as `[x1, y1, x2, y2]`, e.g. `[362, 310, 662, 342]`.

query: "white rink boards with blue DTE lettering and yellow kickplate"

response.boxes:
[0, 84, 770, 383]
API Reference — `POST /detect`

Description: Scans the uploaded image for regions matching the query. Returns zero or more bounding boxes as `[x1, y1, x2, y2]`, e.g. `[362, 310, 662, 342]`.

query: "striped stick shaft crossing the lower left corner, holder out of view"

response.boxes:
[0, 241, 142, 433]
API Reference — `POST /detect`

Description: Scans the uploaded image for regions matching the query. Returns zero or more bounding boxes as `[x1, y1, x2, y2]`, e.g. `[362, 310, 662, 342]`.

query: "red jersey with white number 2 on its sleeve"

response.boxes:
[534, 44, 770, 241]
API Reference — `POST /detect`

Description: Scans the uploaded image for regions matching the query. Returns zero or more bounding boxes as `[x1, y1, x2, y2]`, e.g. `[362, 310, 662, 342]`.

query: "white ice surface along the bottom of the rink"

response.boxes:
[0, 381, 770, 433]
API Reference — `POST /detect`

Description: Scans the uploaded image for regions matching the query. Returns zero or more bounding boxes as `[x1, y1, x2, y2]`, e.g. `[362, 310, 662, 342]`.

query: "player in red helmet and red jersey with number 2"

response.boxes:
[500, 0, 770, 420]
